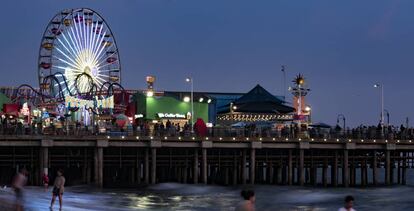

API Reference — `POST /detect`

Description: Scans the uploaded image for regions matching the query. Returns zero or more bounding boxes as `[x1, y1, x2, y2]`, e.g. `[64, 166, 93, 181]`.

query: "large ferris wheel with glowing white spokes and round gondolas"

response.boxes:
[38, 8, 121, 102]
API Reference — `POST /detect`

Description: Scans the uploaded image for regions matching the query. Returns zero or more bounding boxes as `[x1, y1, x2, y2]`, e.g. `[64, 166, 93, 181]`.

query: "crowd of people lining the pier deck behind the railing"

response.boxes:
[0, 116, 414, 140]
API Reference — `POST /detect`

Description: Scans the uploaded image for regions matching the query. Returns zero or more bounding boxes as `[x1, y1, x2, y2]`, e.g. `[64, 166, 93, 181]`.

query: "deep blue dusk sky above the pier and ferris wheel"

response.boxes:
[0, 0, 414, 126]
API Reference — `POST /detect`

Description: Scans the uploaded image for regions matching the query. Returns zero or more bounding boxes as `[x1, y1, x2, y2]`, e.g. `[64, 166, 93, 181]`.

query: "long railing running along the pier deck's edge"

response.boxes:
[0, 127, 414, 141]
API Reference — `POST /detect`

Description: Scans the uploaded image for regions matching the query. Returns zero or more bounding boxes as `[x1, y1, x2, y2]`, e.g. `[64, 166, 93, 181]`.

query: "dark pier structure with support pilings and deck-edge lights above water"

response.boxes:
[0, 135, 414, 187]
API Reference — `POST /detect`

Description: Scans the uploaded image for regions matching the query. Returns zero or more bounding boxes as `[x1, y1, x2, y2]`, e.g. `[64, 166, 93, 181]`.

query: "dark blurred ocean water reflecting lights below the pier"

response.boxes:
[0, 183, 414, 211]
